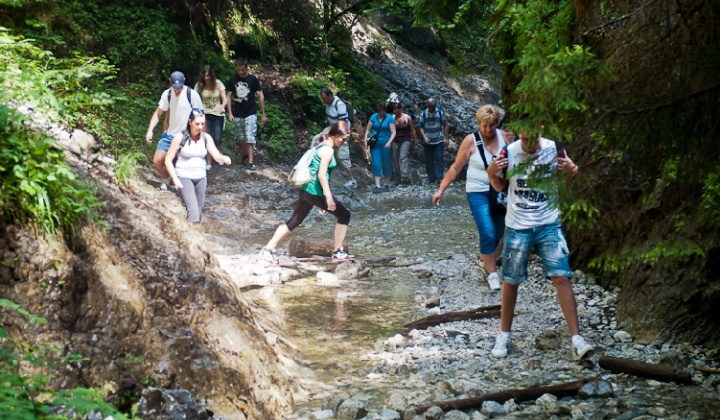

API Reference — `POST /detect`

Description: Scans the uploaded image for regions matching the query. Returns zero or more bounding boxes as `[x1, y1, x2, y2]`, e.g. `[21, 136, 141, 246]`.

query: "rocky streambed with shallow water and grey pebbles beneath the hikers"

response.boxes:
[198, 167, 720, 419]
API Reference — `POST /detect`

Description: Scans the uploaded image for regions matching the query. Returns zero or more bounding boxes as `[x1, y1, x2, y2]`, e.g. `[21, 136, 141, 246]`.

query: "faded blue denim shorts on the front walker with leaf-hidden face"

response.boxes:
[502, 219, 572, 285]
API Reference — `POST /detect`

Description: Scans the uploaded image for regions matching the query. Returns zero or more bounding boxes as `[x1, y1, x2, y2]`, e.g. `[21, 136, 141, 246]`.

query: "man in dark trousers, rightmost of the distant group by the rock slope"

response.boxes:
[418, 98, 450, 184]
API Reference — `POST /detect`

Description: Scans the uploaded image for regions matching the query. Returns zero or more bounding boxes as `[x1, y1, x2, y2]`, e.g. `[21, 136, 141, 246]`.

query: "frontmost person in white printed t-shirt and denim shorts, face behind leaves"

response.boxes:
[487, 114, 594, 360]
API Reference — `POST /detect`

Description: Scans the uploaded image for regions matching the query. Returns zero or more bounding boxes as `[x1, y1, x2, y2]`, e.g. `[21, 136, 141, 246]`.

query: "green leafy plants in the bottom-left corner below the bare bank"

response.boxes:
[0, 299, 128, 420]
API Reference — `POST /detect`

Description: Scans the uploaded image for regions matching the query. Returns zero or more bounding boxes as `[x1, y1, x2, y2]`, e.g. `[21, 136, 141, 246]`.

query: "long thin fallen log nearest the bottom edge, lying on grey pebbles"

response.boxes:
[415, 378, 600, 414]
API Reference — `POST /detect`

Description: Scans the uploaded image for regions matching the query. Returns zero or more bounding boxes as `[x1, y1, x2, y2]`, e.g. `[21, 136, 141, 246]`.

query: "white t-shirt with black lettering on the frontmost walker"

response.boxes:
[498, 137, 560, 230]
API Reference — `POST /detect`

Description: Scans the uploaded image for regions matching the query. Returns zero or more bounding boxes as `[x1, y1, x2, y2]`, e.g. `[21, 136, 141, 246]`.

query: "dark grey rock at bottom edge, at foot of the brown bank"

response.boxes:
[137, 387, 212, 420]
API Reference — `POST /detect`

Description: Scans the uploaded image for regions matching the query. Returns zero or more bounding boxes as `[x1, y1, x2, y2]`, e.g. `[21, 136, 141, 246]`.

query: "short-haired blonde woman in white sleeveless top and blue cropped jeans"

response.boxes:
[432, 105, 505, 290]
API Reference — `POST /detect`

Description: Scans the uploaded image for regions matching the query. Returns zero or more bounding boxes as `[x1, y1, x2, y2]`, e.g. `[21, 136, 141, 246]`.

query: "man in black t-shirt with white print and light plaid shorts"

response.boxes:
[227, 57, 267, 171]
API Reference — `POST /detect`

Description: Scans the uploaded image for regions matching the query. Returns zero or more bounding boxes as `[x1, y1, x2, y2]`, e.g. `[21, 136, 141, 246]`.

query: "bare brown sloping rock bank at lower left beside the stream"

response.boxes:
[0, 129, 292, 420]
